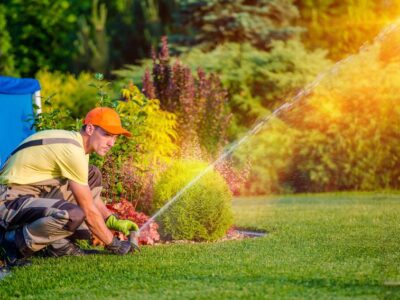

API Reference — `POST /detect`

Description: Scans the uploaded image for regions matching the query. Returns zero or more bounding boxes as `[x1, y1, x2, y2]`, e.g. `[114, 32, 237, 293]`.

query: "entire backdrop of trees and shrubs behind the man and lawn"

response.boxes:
[0, 0, 400, 197]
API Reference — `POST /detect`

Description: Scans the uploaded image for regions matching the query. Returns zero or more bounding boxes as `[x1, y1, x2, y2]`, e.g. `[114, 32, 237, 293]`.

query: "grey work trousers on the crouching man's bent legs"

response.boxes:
[0, 138, 102, 255]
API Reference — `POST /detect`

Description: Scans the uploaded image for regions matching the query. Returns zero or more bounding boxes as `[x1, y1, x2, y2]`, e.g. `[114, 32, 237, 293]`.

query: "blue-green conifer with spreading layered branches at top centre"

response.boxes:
[172, 0, 301, 51]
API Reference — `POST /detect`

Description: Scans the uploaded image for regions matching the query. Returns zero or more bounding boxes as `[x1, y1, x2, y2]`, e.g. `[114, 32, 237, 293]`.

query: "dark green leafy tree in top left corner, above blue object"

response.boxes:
[3, 0, 91, 76]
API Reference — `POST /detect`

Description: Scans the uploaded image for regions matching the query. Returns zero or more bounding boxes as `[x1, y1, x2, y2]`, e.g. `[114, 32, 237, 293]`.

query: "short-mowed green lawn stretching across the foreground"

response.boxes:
[0, 193, 400, 299]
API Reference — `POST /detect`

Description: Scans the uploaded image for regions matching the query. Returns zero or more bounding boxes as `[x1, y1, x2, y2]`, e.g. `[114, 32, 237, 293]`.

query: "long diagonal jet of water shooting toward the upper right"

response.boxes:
[135, 19, 400, 237]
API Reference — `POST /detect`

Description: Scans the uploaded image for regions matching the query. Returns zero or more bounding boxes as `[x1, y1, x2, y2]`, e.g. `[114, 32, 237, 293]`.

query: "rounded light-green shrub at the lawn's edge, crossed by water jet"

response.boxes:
[153, 160, 233, 241]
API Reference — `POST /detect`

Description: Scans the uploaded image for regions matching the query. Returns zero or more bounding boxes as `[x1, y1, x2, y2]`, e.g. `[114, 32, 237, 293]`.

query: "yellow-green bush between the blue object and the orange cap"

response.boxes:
[36, 70, 97, 119]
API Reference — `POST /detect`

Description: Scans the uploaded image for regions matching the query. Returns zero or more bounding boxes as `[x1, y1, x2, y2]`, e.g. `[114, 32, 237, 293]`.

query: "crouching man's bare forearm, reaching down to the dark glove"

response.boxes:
[70, 180, 113, 245]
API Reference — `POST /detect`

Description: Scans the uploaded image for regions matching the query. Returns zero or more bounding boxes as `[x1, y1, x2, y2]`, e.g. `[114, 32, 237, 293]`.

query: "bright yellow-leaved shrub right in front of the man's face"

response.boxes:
[98, 84, 177, 206]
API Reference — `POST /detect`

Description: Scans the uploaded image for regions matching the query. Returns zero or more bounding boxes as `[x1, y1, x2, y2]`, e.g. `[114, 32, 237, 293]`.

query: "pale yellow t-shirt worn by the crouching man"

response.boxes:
[0, 130, 89, 185]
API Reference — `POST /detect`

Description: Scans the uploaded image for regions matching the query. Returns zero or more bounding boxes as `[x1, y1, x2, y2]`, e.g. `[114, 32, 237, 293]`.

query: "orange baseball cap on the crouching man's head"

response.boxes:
[83, 107, 132, 137]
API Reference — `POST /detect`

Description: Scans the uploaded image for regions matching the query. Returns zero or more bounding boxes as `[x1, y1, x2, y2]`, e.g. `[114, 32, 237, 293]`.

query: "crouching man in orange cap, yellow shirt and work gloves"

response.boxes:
[0, 107, 138, 267]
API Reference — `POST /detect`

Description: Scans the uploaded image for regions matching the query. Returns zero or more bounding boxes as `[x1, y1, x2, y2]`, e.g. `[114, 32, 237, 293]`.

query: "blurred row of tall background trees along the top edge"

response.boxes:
[0, 0, 400, 76]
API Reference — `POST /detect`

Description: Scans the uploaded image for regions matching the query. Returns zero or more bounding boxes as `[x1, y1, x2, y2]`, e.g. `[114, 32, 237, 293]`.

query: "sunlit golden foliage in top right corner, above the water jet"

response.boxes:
[296, 0, 400, 60]
